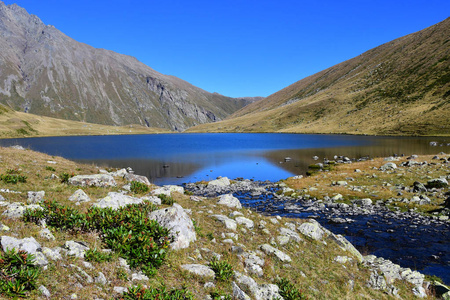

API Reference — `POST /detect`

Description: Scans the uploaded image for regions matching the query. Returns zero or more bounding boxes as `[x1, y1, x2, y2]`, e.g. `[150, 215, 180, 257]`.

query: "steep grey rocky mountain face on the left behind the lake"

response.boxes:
[0, 1, 252, 131]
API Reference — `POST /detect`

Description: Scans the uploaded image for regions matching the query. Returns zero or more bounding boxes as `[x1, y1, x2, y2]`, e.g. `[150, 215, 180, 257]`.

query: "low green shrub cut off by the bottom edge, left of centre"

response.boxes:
[117, 285, 194, 300]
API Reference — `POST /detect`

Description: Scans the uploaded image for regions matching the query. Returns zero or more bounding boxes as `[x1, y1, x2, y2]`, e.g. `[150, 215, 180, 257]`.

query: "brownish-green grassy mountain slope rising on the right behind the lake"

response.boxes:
[191, 18, 450, 135]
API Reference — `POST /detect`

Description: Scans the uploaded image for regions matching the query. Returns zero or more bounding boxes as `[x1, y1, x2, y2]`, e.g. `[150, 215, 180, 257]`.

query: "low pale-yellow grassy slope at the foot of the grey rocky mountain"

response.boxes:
[0, 105, 169, 138]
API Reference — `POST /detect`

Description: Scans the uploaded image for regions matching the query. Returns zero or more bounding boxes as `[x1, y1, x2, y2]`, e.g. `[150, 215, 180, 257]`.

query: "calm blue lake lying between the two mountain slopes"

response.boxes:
[0, 133, 450, 185]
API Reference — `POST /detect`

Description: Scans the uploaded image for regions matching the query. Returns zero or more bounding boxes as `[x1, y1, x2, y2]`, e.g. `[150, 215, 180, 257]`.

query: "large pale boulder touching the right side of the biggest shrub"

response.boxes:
[149, 203, 197, 250]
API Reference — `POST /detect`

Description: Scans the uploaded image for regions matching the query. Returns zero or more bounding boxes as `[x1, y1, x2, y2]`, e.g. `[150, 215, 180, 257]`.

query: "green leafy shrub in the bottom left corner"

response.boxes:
[0, 249, 41, 297]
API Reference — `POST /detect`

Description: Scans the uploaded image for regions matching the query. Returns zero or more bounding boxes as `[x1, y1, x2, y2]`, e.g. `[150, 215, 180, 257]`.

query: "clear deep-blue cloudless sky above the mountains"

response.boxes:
[4, 0, 450, 97]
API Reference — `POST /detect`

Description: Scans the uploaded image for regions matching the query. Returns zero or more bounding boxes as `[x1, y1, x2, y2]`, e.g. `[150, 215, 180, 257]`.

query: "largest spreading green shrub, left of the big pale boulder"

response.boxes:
[24, 201, 171, 276]
